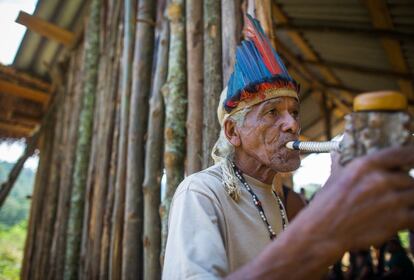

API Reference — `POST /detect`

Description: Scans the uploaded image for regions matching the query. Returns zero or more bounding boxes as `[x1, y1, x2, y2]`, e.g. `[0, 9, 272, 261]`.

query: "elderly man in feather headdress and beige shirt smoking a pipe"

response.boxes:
[163, 17, 414, 279]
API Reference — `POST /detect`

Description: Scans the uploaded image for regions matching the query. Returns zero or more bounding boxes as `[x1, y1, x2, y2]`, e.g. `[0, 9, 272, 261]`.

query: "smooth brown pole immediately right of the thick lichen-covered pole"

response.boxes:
[186, 0, 203, 175]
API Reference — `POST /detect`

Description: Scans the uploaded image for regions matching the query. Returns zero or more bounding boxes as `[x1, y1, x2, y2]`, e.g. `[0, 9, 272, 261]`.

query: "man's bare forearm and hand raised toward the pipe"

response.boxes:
[229, 147, 414, 279]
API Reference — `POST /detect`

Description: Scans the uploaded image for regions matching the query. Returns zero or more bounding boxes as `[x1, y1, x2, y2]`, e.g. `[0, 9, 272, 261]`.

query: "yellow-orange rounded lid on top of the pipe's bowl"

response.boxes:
[354, 91, 407, 112]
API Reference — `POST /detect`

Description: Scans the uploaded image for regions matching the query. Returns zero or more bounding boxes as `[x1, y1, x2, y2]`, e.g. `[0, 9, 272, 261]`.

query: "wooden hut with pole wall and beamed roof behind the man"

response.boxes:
[0, 0, 414, 279]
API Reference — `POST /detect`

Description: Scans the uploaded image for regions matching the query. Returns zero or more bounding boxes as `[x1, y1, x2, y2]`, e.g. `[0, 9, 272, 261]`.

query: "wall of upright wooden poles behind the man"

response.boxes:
[21, 0, 260, 279]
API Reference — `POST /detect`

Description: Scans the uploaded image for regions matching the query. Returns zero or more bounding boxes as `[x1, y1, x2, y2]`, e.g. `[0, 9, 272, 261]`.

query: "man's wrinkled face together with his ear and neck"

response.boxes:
[224, 97, 300, 183]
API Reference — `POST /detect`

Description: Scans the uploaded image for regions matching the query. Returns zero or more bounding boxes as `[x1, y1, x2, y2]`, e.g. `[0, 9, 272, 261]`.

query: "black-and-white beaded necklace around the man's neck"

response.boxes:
[231, 162, 287, 240]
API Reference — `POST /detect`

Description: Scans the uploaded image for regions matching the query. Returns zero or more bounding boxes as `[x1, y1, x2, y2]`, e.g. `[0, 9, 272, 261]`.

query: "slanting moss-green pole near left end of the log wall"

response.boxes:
[64, 0, 101, 279]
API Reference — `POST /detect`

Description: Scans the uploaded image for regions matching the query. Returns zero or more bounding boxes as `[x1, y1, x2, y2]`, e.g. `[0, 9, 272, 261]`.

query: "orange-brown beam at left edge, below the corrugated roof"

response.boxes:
[0, 80, 50, 104]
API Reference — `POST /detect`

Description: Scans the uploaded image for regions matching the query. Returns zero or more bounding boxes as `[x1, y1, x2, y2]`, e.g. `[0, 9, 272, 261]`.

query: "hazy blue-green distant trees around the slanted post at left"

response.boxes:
[0, 161, 35, 227]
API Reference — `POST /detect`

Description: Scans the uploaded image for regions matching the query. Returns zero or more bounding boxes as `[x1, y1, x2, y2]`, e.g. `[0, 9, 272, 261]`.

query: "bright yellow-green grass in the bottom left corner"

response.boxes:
[0, 219, 27, 280]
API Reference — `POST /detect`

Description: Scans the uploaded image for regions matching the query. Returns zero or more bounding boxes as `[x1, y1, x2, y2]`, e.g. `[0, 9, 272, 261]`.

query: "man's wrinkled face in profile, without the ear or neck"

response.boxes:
[237, 97, 300, 172]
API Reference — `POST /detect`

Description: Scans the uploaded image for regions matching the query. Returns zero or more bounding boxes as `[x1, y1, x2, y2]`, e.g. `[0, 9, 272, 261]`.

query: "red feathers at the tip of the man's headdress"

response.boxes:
[245, 16, 282, 75]
